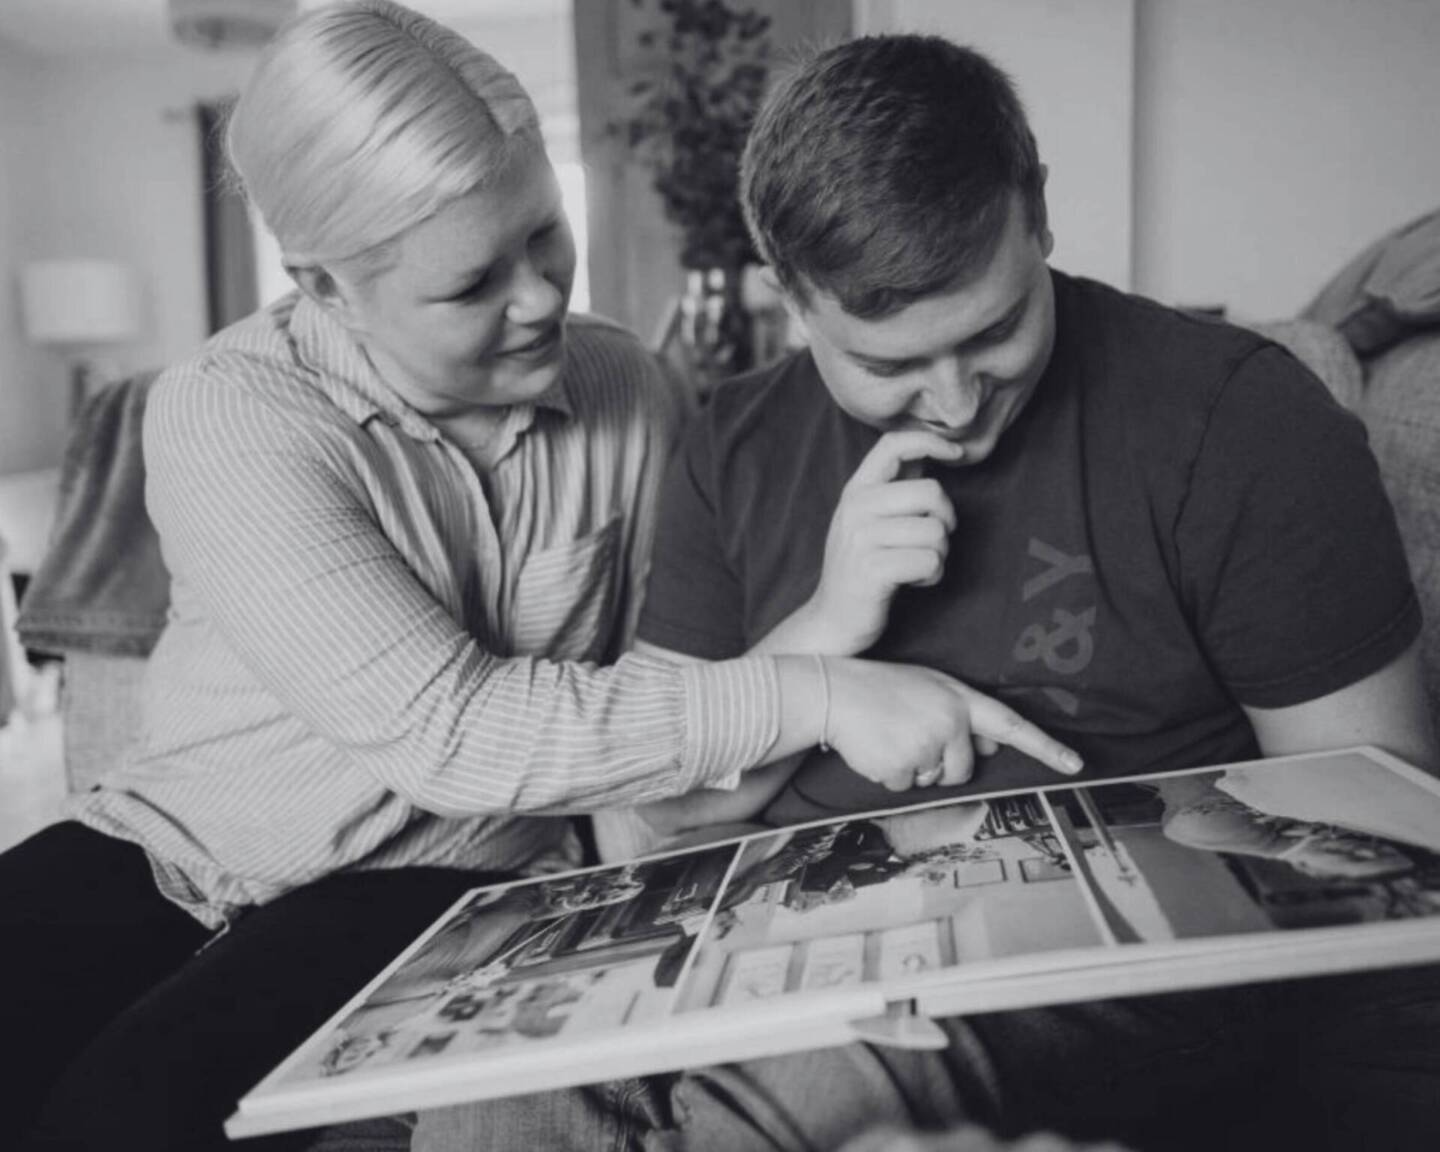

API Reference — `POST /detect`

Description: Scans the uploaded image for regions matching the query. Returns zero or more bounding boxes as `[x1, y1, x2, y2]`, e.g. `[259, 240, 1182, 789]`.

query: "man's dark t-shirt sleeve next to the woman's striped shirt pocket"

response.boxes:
[638, 413, 746, 660]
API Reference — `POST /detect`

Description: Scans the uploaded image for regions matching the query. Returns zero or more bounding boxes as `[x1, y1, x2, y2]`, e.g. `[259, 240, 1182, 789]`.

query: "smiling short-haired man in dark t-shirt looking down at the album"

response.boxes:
[418, 36, 1440, 1152]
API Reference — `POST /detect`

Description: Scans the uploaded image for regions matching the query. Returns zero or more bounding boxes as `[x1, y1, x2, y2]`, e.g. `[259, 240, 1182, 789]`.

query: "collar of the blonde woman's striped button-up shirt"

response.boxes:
[289, 291, 575, 441]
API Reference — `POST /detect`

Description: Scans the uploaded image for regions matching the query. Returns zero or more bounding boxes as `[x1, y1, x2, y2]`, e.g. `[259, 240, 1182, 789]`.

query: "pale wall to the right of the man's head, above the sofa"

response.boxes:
[855, 0, 1440, 318]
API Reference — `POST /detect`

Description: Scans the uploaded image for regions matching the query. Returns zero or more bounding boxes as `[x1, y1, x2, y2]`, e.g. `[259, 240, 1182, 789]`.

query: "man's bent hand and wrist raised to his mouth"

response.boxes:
[762, 431, 965, 655]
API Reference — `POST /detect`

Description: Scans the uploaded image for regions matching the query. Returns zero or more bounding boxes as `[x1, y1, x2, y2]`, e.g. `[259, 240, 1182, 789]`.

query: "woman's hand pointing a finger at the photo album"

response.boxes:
[825, 660, 1083, 792]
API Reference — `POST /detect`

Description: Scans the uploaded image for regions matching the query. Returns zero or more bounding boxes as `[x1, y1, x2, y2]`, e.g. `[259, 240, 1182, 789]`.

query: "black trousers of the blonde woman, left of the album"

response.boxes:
[0, 824, 503, 1152]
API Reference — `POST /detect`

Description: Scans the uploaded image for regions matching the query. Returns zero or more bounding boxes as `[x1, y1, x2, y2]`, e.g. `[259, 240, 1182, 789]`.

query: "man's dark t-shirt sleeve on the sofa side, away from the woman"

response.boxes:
[1175, 346, 1420, 708]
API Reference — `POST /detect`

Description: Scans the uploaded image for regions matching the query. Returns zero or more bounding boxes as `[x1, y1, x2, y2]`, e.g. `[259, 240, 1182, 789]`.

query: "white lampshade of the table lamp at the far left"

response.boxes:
[20, 261, 141, 344]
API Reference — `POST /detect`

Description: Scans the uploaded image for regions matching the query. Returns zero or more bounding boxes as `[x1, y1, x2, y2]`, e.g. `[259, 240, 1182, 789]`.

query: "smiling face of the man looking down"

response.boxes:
[792, 196, 1056, 464]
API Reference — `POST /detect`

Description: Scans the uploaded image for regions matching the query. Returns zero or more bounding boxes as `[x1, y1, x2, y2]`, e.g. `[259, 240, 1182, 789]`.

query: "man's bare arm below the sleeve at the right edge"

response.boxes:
[1246, 639, 1440, 775]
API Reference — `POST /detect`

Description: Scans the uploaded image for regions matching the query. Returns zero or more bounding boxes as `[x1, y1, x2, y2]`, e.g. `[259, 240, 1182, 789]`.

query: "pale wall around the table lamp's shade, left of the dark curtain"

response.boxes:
[0, 38, 249, 472]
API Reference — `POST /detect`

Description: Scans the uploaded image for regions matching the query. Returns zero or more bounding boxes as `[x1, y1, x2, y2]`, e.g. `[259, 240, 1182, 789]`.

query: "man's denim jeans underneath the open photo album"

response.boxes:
[412, 968, 1440, 1152]
